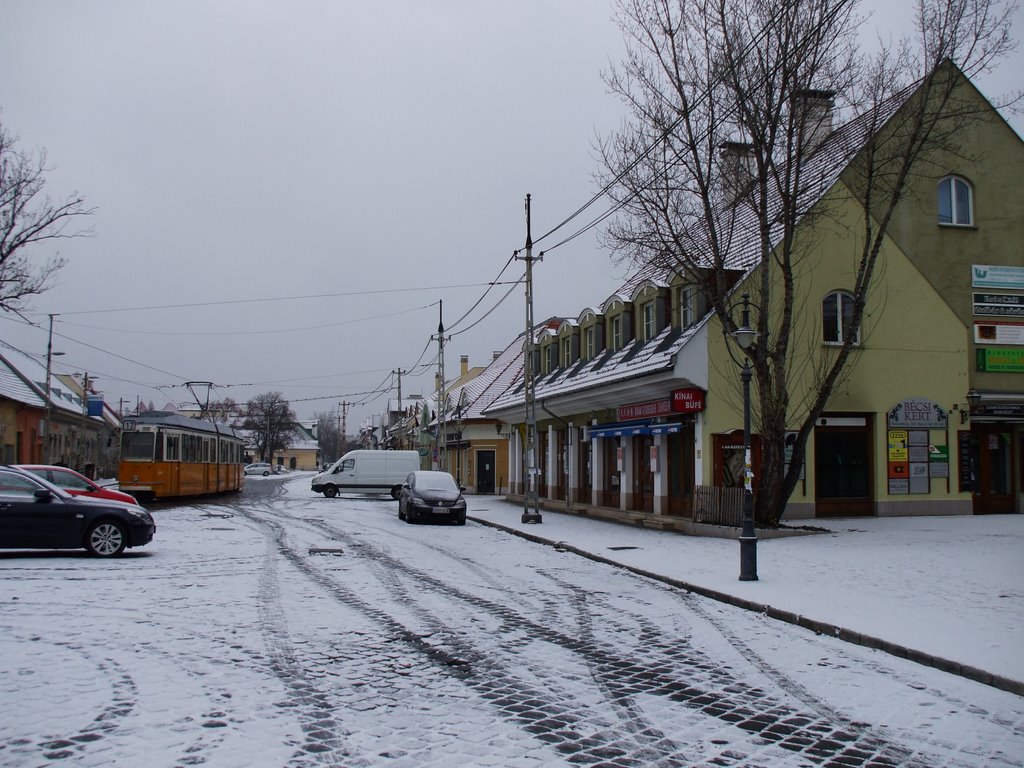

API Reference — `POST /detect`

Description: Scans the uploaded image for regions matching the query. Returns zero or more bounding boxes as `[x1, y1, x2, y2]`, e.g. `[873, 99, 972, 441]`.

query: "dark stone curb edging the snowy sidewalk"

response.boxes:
[467, 515, 1024, 696]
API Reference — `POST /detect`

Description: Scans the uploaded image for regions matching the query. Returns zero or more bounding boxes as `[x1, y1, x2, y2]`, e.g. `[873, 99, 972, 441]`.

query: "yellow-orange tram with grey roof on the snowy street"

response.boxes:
[118, 411, 245, 503]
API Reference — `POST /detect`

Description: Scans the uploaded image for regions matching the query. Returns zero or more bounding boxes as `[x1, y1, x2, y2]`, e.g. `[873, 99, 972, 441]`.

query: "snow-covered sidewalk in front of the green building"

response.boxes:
[468, 496, 1024, 682]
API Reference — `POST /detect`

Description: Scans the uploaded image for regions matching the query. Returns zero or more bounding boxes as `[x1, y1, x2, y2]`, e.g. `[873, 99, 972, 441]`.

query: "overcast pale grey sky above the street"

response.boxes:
[0, 0, 1024, 431]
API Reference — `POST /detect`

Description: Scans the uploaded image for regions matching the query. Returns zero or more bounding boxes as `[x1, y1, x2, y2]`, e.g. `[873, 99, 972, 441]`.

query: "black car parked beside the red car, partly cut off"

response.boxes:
[0, 466, 157, 557]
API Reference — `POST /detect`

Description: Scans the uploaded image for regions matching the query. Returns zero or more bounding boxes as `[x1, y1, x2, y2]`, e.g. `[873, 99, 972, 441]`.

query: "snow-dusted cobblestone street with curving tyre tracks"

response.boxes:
[0, 474, 1024, 768]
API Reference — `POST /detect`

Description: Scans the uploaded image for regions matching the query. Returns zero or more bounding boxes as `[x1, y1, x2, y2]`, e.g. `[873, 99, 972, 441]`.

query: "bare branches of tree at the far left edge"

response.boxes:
[0, 123, 95, 311]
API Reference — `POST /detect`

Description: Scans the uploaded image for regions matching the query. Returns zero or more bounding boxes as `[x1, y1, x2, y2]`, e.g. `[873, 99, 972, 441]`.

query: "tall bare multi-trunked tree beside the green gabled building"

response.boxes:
[599, 0, 1016, 524]
